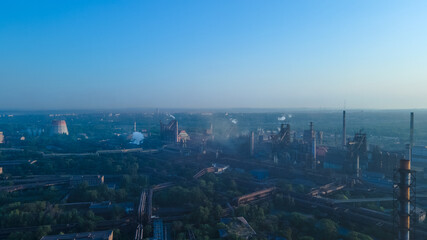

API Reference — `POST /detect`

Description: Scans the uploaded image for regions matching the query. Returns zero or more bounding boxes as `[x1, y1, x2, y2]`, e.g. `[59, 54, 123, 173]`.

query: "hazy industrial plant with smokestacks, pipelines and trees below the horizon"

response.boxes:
[0, 111, 427, 240]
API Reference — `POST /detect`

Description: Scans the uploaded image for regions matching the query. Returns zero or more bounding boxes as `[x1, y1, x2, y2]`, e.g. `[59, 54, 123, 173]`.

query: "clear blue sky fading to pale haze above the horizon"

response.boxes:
[0, 0, 427, 109]
